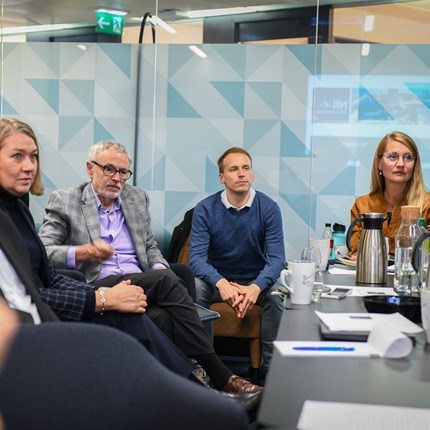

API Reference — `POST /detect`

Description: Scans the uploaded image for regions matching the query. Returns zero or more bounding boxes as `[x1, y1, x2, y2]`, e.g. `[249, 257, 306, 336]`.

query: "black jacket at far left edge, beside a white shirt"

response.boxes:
[0, 205, 58, 322]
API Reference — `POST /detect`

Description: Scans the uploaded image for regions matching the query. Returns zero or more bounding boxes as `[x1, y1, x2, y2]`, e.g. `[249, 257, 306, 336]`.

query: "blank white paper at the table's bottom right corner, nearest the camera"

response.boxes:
[297, 400, 430, 430]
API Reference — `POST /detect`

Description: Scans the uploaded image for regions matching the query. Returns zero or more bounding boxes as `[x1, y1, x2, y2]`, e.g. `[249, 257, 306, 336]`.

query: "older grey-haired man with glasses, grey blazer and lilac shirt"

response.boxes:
[39, 141, 262, 400]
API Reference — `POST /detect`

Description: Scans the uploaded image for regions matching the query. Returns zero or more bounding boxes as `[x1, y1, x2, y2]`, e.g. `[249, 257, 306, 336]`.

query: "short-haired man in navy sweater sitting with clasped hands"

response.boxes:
[190, 148, 286, 375]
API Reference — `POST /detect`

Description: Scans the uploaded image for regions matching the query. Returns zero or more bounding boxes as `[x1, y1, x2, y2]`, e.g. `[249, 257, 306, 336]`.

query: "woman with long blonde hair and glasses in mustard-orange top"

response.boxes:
[350, 131, 430, 258]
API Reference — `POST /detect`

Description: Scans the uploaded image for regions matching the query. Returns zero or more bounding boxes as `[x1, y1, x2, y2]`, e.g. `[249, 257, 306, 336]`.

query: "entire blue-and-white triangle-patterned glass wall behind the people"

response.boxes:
[1, 43, 430, 258]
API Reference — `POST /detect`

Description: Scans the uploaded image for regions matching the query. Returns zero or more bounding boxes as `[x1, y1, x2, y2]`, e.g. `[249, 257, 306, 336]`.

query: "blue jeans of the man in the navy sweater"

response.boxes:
[196, 278, 284, 375]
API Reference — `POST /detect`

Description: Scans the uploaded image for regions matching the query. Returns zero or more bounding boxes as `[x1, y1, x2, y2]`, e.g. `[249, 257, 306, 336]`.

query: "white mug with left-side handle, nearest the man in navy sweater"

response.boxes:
[279, 260, 315, 305]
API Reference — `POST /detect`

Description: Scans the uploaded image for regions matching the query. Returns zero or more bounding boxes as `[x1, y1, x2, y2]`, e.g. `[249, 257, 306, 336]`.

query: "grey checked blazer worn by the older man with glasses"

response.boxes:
[39, 183, 169, 282]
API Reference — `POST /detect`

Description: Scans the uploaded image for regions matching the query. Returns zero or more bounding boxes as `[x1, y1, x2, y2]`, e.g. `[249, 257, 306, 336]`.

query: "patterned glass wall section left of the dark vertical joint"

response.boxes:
[1, 43, 137, 224]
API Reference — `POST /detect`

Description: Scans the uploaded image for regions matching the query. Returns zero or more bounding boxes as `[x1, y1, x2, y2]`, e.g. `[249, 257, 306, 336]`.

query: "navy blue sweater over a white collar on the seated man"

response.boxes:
[190, 191, 286, 289]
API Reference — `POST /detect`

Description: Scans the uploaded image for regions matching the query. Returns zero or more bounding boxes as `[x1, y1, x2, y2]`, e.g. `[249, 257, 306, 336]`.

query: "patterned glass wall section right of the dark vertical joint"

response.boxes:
[139, 44, 430, 258]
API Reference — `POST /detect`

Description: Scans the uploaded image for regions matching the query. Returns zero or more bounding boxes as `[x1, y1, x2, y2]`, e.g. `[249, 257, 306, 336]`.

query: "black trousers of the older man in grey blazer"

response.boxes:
[96, 269, 214, 357]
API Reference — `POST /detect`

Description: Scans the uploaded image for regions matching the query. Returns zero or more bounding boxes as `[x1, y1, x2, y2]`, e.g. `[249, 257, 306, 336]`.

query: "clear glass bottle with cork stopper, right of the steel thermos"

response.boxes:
[394, 206, 422, 294]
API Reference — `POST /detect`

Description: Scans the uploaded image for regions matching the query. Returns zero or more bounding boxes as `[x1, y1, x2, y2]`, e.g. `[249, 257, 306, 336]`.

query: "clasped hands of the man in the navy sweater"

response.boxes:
[216, 279, 261, 318]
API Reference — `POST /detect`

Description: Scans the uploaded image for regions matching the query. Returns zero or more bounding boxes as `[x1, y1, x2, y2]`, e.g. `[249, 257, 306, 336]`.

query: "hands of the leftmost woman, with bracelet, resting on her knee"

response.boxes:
[96, 279, 148, 314]
